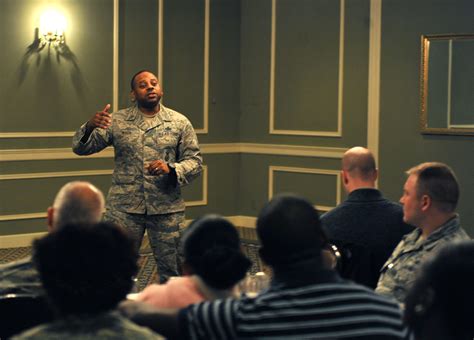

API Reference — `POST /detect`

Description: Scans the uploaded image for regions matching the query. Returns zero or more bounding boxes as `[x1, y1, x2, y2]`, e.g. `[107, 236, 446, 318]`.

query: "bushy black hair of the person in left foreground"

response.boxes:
[33, 222, 138, 315]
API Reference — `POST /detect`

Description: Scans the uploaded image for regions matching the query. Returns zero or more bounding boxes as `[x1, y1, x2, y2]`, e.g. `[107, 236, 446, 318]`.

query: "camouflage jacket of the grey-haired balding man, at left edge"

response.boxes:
[0, 257, 44, 296]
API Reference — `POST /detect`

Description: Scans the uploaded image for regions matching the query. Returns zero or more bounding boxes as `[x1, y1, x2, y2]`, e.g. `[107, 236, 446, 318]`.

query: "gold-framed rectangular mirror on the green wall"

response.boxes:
[420, 33, 474, 135]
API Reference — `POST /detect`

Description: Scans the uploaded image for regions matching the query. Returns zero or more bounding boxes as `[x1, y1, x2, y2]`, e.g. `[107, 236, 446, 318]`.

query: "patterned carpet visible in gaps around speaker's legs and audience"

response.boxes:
[0, 237, 263, 291]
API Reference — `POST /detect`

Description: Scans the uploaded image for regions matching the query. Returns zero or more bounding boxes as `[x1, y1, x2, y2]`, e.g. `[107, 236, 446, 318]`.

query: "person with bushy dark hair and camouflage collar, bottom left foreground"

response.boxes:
[12, 223, 162, 339]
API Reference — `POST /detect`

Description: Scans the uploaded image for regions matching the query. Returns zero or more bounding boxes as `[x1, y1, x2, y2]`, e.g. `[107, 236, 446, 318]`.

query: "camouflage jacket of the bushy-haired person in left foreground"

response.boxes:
[13, 312, 164, 340]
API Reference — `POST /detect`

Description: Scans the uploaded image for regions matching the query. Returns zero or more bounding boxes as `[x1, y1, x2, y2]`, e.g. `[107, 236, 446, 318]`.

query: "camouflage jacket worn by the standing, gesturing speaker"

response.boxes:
[73, 105, 202, 215]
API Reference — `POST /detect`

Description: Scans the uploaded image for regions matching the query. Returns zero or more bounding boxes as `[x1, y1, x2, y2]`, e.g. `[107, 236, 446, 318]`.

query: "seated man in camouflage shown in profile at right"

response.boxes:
[376, 162, 469, 304]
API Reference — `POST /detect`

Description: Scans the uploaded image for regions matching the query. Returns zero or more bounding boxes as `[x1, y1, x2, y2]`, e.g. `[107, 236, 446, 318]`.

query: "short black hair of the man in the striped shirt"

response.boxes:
[257, 194, 328, 265]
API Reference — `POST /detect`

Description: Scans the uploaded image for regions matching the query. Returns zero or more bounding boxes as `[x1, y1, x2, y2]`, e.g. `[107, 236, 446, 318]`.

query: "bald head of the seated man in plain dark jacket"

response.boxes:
[342, 146, 377, 181]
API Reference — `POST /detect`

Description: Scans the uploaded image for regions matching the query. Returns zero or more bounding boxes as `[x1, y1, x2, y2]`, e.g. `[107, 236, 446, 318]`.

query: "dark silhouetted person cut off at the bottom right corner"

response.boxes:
[405, 241, 474, 340]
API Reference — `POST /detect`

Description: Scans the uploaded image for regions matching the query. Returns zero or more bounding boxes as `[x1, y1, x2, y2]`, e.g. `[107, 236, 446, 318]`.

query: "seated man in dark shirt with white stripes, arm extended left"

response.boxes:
[121, 195, 409, 340]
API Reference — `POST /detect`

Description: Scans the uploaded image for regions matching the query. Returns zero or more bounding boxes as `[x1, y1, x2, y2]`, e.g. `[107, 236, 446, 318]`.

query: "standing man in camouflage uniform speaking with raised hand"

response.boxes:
[73, 70, 202, 282]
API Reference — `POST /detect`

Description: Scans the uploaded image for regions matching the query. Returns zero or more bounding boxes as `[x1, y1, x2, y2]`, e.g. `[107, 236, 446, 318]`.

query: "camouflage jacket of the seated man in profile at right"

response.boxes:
[375, 215, 469, 303]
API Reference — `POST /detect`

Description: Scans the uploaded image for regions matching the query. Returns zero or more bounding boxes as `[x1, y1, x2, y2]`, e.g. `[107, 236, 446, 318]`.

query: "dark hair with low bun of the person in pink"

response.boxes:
[182, 215, 251, 289]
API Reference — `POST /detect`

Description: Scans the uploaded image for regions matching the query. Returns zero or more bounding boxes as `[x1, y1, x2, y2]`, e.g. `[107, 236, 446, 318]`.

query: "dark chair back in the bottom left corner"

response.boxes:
[0, 294, 53, 339]
